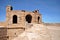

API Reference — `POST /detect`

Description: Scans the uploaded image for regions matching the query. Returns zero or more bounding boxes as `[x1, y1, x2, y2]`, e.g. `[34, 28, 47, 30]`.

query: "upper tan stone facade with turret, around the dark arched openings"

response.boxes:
[6, 5, 42, 25]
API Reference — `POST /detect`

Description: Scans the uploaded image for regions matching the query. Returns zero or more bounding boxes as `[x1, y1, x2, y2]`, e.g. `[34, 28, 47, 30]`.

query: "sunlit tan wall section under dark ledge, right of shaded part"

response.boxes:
[7, 28, 24, 40]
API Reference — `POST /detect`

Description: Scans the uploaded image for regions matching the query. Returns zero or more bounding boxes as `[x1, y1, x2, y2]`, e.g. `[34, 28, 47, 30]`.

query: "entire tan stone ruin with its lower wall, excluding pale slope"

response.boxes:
[0, 5, 42, 40]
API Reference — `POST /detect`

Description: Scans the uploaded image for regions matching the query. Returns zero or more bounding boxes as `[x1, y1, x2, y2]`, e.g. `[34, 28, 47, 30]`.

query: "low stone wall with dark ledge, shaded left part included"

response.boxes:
[0, 27, 25, 40]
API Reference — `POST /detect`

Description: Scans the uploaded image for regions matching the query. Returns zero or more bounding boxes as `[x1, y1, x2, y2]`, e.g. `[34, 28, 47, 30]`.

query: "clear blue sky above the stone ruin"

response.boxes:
[0, 0, 60, 23]
